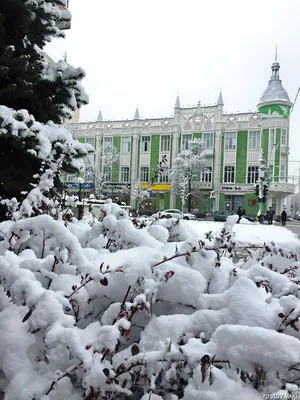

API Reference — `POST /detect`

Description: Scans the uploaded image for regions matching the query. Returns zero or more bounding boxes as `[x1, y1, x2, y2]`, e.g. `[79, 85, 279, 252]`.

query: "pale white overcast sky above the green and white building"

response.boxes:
[46, 0, 300, 175]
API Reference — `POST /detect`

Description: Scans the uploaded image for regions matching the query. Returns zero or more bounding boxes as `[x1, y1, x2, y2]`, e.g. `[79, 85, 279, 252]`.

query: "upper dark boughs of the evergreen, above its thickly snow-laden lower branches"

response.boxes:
[0, 0, 88, 123]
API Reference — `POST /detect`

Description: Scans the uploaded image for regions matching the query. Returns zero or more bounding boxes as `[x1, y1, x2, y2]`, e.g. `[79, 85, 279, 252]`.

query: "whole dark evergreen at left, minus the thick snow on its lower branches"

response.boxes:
[0, 0, 88, 219]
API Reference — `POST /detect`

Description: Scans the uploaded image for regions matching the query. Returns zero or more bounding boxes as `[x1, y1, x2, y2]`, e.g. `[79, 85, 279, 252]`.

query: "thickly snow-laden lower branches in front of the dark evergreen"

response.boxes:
[0, 106, 93, 220]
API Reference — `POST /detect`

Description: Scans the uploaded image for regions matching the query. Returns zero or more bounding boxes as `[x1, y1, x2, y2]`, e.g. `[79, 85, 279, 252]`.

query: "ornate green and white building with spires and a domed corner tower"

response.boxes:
[67, 57, 294, 215]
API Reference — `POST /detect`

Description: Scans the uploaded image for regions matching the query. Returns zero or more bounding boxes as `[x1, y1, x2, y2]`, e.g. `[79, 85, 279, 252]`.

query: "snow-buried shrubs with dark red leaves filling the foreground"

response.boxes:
[0, 208, 300, 400]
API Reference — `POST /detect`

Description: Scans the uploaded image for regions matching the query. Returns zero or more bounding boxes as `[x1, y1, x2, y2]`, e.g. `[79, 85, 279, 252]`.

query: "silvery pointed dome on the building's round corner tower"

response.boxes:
[257, 61, 293, 108]
